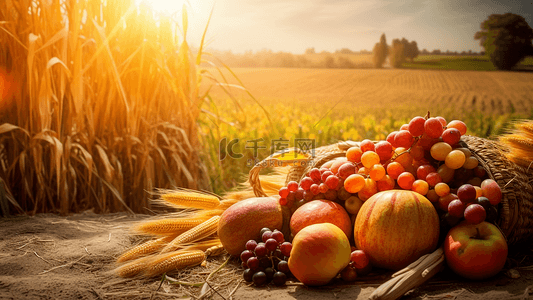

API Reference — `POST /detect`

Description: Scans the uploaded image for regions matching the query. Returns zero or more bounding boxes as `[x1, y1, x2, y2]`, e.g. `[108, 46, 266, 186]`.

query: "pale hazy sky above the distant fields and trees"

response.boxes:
[174, 0, 533, 54]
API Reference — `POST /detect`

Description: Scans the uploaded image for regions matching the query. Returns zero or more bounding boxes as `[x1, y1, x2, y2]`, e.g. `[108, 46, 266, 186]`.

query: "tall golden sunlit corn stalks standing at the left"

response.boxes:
[0, 0, 209, 214]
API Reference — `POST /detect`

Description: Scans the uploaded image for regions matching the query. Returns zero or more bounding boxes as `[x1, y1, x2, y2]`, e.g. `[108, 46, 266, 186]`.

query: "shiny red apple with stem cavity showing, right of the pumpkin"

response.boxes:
[444, 221, 507, 280]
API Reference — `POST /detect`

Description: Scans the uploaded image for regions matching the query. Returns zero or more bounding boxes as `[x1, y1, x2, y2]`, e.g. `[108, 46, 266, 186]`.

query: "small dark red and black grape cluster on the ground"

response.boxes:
[241, 228, 292, 286]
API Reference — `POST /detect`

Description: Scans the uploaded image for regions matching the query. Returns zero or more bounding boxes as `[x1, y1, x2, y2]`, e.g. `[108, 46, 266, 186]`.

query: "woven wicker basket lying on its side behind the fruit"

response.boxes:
[249, 136, 533, 246]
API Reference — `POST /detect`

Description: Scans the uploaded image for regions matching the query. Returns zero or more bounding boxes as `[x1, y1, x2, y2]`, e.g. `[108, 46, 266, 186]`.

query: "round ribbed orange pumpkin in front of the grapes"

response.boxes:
[354, 190, 440, 270]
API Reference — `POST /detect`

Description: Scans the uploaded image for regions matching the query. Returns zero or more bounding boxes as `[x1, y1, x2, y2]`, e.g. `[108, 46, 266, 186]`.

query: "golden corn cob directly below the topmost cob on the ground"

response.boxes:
[135, 216, 210, 234]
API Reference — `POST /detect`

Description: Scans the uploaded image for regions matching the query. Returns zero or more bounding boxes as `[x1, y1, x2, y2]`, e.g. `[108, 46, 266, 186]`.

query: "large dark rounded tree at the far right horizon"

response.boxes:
[474, 13, 533, 70]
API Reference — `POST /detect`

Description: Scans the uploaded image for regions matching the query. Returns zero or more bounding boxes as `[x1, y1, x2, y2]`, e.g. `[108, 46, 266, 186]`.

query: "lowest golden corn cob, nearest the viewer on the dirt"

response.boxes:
[145, 250, 205, 277]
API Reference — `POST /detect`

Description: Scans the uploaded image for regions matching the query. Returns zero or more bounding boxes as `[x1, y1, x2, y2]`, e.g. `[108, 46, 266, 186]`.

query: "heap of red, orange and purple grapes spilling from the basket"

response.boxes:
[279, 113, 501, 227]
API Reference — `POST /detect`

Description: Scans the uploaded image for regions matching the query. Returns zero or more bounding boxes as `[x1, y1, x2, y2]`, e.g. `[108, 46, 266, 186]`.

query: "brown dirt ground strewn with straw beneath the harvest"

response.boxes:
[0, 212, 533, 300]
